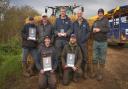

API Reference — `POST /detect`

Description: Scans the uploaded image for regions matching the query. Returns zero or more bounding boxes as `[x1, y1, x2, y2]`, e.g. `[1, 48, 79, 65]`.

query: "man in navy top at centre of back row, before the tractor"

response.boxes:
[54, 7, 72, 77]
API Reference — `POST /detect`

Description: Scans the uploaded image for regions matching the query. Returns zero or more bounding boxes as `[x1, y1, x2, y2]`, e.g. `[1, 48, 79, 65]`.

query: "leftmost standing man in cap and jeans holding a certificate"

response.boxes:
[21, 17, 38, 77]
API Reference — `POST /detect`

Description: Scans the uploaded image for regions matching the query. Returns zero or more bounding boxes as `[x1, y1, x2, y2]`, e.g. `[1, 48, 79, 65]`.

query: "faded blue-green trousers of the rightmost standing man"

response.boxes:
[93, 41, 107, 64]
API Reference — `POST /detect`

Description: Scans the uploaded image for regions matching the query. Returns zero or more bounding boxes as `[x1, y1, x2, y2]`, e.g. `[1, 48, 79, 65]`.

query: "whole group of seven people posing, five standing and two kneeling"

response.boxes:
[21, 7, 109, 89]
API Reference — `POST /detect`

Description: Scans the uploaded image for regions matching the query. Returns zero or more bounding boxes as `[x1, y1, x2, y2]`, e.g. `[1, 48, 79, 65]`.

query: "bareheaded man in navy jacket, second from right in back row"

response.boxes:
[73, 10, 90, 79]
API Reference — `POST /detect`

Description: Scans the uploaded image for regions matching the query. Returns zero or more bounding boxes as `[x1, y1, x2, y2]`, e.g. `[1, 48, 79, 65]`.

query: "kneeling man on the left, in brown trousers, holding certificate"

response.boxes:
[38, 36, 58, 89]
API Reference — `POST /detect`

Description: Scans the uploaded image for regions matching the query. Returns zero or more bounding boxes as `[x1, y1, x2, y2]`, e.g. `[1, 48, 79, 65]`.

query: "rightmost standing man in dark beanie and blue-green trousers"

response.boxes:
[92, 8, 109, 81]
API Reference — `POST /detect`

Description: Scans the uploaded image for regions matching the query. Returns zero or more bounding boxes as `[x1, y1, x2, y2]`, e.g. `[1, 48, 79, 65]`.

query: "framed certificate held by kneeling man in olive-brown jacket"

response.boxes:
[67, 53, 75, 67]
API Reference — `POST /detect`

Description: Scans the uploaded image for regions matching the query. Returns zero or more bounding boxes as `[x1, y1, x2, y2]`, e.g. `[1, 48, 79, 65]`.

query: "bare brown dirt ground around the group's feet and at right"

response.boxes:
[8, 47, 128, 89]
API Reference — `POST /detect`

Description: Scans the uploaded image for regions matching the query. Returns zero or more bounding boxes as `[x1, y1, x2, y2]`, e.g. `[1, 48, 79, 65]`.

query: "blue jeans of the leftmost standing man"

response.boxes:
[22, 48, 39, 68]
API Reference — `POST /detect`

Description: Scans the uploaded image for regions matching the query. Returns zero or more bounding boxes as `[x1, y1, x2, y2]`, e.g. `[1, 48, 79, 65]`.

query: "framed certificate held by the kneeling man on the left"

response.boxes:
[42, 57, 52, 71]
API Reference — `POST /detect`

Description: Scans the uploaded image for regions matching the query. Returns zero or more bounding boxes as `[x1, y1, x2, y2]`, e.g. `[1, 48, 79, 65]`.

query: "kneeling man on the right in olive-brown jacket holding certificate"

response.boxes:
[61, 34, 82, 85]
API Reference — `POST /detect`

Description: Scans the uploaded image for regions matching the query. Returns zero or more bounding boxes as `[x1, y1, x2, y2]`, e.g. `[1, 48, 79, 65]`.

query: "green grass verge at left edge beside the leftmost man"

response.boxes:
[0, 44, 21, 89]
